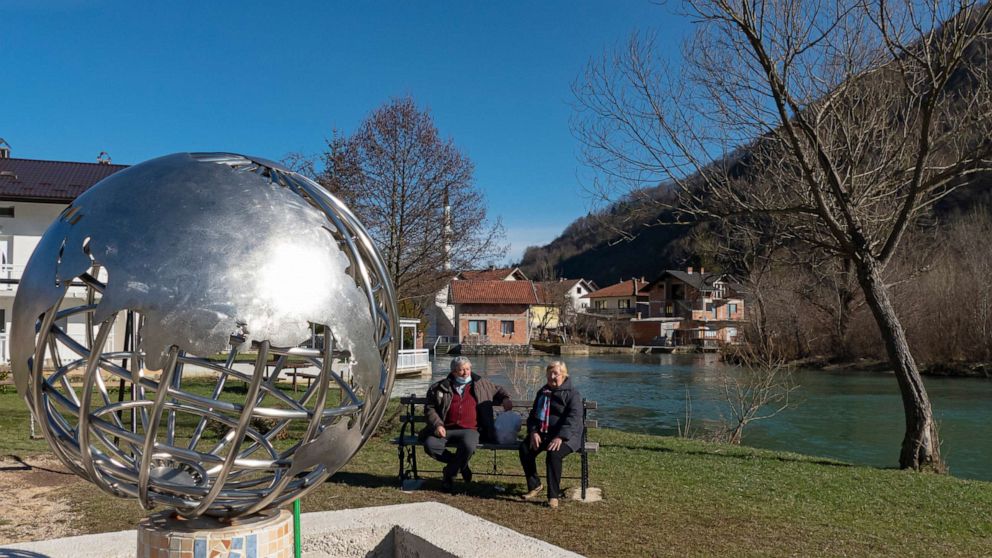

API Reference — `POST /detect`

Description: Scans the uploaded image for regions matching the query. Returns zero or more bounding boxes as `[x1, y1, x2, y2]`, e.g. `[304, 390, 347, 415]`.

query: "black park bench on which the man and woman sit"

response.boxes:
[392, 394, 599, 500]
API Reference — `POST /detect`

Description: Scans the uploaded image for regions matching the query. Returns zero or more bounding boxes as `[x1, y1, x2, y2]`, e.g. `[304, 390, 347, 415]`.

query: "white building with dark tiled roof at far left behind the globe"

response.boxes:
[0, 145, 127, 362]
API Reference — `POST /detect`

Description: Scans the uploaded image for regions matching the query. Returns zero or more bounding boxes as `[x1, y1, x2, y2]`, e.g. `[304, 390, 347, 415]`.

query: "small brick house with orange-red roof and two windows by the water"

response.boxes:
[449, 279, 540, 352]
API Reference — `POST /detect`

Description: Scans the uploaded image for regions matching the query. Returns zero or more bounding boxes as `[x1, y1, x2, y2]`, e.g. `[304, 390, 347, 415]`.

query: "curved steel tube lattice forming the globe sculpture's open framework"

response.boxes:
[14, 154, 399, 517]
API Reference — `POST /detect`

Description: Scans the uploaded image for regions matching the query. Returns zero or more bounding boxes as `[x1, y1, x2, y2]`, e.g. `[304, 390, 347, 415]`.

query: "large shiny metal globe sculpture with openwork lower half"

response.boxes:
[11, 153, 397, 517]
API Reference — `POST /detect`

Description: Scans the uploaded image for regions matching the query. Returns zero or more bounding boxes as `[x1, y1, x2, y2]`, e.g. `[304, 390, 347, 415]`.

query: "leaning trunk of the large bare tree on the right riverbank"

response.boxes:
[855, 255, 945, 473]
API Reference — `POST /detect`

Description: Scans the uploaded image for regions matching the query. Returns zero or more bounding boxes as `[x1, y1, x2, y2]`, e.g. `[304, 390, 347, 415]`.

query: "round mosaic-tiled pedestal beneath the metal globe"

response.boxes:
[136, 510, 293, 558]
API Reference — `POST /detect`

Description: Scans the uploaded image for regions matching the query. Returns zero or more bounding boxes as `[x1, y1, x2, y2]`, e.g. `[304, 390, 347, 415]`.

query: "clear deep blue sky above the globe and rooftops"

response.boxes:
[0, 0, 689, 261]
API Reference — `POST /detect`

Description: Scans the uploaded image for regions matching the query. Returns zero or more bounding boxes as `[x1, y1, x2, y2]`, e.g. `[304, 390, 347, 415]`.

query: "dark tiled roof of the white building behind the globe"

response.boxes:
[0, 159, 127, 203]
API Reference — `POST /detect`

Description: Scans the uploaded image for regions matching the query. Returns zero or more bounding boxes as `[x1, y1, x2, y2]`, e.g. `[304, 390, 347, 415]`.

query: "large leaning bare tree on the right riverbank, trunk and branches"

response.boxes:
[575, 0, 992, 471]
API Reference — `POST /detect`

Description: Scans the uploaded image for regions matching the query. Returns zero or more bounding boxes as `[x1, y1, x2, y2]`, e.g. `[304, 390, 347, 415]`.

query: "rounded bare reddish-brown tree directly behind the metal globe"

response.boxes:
[320, 98, 505, 306]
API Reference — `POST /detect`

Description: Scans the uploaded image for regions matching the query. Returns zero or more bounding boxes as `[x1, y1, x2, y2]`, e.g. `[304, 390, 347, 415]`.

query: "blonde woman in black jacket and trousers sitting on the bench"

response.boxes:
[520, 360, 582, 508]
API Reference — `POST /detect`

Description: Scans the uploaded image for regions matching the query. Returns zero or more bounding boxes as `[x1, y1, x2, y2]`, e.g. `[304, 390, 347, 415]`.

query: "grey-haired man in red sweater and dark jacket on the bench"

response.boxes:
[420, 356, 513, 492]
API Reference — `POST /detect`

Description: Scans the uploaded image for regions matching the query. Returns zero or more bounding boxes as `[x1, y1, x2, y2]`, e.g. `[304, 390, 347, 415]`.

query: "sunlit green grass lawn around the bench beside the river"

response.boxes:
[0, 391, 992, 556]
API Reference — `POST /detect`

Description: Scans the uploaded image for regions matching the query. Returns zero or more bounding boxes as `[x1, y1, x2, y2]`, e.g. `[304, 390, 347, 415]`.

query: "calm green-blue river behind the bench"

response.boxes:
[393, 354, 992, 481]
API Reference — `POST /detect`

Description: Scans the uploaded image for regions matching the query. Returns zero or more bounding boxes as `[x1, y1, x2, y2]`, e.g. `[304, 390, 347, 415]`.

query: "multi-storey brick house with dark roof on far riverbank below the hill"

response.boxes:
[631, 267, 744, 348]
